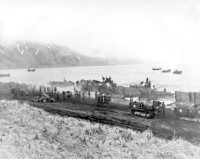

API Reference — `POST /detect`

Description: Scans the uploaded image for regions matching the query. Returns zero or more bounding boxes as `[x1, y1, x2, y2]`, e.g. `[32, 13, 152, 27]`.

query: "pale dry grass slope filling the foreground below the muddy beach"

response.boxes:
[0, 100, 200, 159]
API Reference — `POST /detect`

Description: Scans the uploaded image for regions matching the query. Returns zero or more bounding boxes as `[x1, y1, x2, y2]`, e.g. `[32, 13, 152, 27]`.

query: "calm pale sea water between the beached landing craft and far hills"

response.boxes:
[0, 64, 200, 92]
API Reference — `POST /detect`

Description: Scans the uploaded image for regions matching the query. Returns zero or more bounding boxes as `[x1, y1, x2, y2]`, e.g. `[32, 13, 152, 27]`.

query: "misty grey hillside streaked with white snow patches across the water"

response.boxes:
[0, 42, 111, 68]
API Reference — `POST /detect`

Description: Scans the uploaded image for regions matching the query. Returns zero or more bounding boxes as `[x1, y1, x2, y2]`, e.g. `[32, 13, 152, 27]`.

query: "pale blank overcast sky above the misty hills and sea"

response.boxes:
[0, 0, 200, 64]
